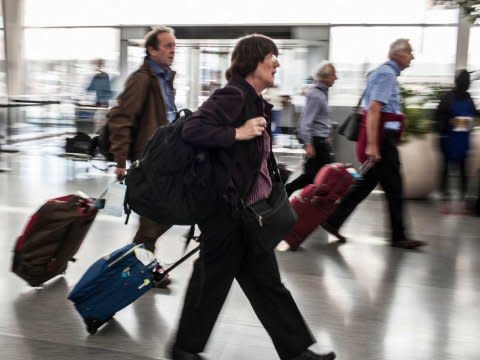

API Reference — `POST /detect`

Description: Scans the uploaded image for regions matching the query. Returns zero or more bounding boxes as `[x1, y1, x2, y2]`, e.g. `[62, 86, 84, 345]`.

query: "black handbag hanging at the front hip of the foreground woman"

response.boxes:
[241, 166, 297, 252]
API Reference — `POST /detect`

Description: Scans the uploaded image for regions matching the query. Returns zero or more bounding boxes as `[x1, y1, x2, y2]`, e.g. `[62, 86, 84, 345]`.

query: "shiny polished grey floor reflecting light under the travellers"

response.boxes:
[0, 140, 480, 360]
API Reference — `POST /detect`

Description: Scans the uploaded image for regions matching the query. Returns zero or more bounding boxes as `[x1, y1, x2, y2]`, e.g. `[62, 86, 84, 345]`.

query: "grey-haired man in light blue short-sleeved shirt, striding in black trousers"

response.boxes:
[322, 39, 425, 249]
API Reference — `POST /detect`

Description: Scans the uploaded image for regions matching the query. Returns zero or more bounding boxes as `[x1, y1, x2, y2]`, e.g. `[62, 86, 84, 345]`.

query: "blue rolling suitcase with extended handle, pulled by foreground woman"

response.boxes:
[68, 244, 199, 334]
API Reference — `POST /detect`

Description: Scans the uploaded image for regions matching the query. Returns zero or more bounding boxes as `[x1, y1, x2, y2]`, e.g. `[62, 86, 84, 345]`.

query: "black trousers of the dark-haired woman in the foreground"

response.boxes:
[175, 204, 315, 360]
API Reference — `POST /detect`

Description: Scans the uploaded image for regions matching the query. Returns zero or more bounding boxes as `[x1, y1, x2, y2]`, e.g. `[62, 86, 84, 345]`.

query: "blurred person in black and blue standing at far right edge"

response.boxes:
[435, 70, 479, 211]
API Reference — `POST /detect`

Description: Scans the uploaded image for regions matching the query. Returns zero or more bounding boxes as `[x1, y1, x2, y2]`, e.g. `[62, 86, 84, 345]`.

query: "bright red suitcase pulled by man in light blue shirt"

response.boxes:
[284, 163, 354, 248]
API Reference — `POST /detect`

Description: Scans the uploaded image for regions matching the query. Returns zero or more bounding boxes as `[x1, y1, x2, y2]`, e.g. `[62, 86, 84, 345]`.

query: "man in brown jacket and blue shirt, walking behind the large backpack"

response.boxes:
[108, 26, 176, 286]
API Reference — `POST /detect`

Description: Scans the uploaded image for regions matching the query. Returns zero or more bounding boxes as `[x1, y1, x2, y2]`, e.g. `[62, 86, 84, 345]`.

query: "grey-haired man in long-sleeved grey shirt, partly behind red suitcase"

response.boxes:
[285, 61, 337, 195]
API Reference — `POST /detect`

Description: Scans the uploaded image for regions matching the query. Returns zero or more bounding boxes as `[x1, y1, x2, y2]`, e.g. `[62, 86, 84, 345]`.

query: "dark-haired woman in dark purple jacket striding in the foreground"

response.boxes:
[171, 34, 335, 360]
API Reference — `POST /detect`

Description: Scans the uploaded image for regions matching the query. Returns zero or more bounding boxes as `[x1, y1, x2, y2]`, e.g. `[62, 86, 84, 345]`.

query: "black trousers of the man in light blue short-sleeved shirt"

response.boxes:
[327, 131, 406, 242]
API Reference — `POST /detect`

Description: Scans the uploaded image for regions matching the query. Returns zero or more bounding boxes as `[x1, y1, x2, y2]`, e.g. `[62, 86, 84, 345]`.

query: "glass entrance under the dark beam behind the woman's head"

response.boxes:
[128, 39, 316, 108]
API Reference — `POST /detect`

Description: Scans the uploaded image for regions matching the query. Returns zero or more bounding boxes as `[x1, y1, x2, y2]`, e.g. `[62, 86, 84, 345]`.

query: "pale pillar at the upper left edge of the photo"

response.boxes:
[2, 0, 25, 97]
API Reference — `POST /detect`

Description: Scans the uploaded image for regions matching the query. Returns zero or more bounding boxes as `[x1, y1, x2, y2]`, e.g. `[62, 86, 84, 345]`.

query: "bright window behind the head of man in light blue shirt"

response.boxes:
[330, 26, 457, 106]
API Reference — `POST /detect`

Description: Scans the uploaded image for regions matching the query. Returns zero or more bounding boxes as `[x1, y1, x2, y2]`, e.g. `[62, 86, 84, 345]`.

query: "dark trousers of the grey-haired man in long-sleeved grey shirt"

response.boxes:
[285, 136, 333, 196]
